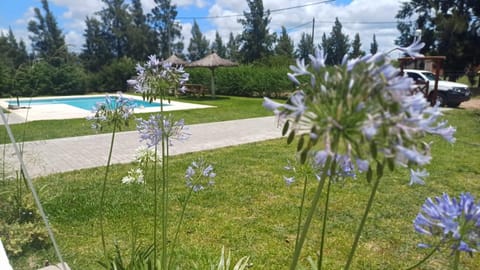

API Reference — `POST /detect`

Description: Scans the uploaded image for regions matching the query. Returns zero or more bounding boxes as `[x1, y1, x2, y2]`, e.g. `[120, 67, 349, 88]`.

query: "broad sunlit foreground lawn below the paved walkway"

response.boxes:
[0, 108, 480, 270]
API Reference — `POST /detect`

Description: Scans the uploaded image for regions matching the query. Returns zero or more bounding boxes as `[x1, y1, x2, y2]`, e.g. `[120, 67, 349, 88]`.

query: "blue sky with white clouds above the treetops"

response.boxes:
[0, 0, 400, 54]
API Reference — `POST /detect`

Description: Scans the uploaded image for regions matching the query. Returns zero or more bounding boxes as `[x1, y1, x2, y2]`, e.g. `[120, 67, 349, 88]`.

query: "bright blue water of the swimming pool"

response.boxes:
[8, 96, 169, 111]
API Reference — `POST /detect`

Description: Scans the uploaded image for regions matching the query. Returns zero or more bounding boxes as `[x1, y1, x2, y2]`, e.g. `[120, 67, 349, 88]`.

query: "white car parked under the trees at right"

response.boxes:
[403, 69, 472, 107]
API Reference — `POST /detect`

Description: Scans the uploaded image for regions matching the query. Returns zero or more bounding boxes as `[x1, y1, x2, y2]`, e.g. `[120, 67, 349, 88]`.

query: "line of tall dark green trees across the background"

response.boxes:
[0, 0, 480, 96]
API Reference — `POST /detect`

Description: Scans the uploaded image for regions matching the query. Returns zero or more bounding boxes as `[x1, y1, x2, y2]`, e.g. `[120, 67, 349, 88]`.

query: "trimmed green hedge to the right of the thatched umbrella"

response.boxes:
[186, 65, 293, 97]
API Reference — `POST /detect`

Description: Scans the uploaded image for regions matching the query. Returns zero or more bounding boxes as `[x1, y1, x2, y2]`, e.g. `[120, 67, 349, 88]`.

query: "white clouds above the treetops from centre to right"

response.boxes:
[205, 0, 400, 51]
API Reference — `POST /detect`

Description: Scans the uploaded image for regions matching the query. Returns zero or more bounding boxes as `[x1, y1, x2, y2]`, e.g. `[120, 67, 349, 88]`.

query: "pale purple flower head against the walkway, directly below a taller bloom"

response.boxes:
[137, 114, 189, 147]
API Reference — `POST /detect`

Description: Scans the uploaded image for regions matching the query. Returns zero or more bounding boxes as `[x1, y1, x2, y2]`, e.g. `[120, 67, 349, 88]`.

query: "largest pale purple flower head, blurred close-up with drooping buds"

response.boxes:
[263, 39, 455, 184]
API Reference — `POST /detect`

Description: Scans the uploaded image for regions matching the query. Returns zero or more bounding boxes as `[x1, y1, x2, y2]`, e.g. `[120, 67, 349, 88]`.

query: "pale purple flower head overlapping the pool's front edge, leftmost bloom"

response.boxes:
[87, 92, 135, 129]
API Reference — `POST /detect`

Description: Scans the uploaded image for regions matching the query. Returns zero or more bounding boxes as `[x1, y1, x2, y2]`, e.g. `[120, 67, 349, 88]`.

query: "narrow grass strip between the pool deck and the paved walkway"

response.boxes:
[0, 96, 272, 144]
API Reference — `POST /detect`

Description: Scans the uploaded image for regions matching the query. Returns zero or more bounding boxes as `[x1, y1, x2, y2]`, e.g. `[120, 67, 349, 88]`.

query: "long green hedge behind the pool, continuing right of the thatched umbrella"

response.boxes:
[0, 58, 293, 97]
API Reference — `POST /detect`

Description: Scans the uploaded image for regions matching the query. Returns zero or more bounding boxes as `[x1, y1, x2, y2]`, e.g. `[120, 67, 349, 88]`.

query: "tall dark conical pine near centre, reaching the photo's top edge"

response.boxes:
[238, 0, 276, 63]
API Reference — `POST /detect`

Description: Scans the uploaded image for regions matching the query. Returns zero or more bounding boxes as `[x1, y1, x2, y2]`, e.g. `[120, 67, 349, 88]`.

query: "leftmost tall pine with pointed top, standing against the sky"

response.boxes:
[28, 0, 68, 66]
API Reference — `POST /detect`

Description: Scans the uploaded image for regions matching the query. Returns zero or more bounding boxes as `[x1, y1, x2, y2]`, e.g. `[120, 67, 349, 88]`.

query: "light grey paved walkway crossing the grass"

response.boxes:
[0, 117, 281, 178]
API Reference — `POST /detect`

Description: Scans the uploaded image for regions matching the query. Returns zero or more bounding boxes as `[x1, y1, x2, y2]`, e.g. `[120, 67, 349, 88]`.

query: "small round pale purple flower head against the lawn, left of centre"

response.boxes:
[185, 160, 217, 192]
